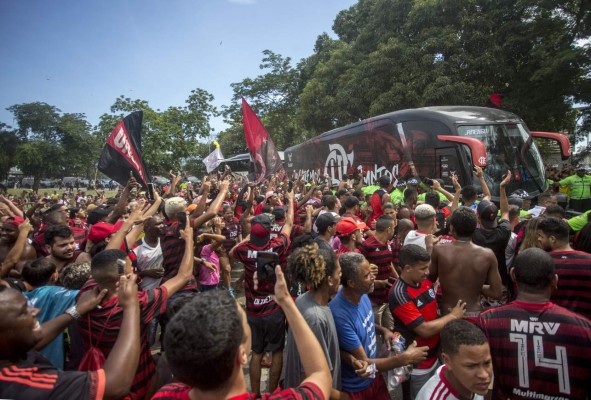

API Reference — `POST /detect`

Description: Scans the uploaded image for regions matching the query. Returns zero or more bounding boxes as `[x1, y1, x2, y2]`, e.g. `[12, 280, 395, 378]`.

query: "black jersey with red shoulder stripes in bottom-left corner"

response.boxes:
[0, 351, 105, 400]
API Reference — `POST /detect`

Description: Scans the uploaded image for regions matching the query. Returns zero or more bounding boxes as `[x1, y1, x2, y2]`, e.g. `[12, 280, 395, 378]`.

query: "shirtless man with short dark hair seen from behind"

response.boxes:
[429, 207, 502, 322]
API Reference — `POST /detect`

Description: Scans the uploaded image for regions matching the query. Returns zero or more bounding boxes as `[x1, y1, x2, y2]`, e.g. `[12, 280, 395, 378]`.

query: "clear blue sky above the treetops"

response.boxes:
[0, 0, 356, 132]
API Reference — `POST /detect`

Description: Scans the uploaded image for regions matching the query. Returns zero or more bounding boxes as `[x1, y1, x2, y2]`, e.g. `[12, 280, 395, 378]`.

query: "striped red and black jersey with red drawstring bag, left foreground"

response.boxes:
[77, 279, 168, 399]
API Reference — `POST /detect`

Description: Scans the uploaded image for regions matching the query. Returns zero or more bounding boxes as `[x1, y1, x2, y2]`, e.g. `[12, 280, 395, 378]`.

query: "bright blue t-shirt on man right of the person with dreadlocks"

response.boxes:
[328, 289, 377, 393]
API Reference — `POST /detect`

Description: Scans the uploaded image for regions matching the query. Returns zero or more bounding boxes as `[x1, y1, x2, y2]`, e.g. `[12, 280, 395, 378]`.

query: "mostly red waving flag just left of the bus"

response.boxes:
[242, 97, 283, 183]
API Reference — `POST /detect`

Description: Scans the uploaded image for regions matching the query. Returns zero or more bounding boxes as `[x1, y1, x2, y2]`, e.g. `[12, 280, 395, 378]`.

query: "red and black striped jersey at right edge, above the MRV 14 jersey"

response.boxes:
[549, 250, 591, 319]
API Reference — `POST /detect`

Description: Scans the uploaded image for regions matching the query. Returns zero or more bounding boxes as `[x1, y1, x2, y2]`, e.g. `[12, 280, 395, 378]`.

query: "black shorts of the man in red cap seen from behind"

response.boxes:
[247, 310, 285, 354]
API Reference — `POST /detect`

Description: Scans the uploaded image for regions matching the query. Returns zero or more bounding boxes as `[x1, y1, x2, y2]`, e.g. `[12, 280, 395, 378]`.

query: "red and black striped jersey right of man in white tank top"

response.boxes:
[160, 220, 197, 291]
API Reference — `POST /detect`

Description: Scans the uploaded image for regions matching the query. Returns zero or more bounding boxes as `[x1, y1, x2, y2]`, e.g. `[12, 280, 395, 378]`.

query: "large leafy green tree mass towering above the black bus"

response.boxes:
[298, 0, 591, 142]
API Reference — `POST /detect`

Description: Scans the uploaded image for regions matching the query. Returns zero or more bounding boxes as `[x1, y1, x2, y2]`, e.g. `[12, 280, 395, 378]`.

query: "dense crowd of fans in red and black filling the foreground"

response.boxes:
[0, 163, 591, 400]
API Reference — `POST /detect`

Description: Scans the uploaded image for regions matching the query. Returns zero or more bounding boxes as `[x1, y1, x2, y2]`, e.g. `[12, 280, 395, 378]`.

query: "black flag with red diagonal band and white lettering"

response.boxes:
[98, 111, 150, 188]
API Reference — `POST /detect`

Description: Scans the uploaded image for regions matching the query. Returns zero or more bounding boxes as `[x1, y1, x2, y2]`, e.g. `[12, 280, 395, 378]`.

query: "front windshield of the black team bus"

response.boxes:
[458, 124, 546, 199]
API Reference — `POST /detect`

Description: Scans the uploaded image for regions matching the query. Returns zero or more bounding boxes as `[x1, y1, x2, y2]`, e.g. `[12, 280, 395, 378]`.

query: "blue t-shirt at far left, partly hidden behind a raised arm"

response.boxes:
[24, 286, 78, 369]
